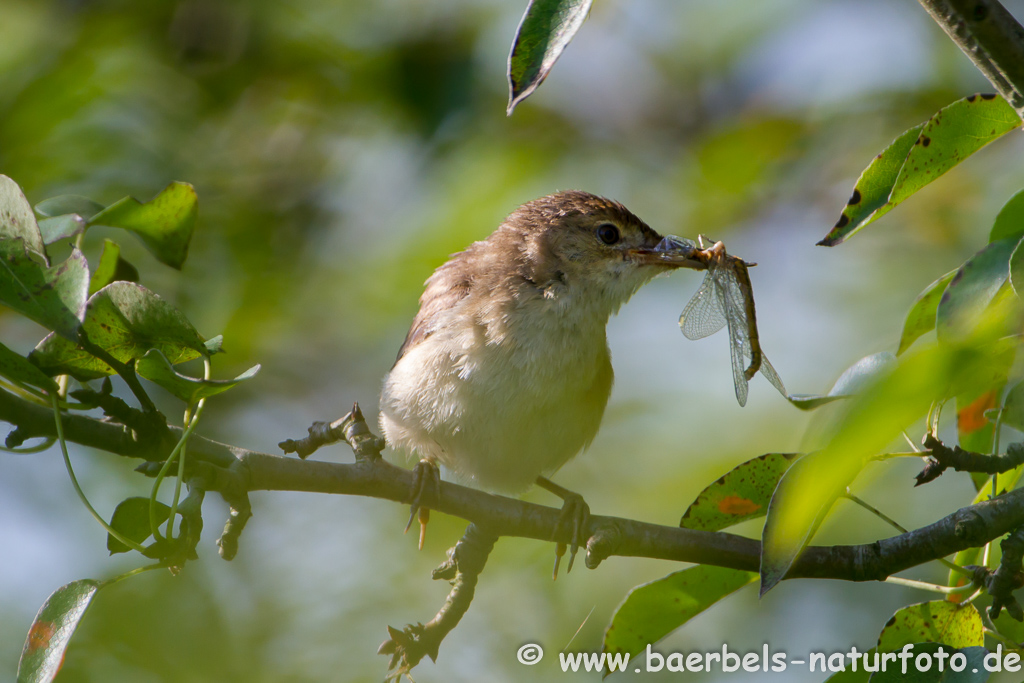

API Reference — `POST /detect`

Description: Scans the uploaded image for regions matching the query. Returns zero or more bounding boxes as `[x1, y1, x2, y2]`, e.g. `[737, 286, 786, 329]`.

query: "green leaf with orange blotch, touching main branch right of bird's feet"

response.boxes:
[679, 453, 800, 531]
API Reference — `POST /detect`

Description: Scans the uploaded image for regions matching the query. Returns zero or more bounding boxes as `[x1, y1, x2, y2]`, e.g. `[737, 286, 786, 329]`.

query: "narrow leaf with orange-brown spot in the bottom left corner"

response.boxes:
[17, 579, 101, 683]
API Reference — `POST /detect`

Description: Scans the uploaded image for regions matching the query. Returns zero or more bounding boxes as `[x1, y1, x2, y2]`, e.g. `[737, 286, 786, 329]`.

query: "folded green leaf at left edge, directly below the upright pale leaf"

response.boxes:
[0, 245, 89, 340]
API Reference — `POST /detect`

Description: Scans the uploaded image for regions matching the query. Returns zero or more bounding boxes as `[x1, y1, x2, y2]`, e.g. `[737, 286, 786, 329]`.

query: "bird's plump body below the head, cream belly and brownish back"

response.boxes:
[381, 286, 612, 492]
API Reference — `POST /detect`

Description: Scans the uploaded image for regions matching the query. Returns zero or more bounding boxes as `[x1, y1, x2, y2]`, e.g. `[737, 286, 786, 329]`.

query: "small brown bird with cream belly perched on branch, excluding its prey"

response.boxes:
[380, 190, 707, 572]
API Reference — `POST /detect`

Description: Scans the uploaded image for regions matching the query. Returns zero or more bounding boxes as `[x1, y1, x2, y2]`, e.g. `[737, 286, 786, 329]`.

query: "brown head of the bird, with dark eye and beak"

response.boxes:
[504, 190, 707, 308]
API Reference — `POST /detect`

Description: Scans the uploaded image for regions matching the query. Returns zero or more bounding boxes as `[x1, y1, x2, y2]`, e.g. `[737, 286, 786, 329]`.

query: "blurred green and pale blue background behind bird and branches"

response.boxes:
[0, 0, 1024, 682]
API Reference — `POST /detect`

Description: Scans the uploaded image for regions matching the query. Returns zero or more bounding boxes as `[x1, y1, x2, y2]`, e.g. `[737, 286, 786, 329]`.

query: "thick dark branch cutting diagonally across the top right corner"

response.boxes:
[919, 0, 1024, 119]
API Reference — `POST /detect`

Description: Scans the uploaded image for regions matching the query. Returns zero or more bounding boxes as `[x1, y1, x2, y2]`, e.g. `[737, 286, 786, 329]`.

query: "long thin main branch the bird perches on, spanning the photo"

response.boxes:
[6, 391, 1024, 582]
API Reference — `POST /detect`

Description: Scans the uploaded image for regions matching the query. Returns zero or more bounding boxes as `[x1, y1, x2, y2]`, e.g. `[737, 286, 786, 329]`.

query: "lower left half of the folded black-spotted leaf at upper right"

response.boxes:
[818, 123, 925, 247]
